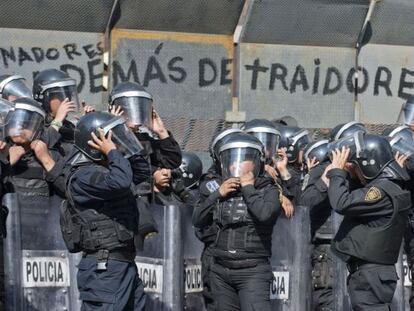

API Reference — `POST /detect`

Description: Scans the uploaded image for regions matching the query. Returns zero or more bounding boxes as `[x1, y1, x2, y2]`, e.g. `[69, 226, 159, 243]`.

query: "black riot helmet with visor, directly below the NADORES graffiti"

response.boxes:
[33, 69, 80, 123]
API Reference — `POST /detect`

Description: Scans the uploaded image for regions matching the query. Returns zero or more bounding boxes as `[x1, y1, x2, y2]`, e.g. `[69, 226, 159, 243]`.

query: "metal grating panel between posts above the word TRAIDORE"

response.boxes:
[243, 0, 369, 47]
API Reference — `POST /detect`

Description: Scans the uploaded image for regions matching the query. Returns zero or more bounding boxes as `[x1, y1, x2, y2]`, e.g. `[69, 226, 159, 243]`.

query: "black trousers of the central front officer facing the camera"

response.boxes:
[210, 262, 273, 311]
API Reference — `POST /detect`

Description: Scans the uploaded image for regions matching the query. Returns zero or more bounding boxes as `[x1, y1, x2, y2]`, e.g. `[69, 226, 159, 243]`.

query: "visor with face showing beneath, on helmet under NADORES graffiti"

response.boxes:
[42, 79, 80, 124]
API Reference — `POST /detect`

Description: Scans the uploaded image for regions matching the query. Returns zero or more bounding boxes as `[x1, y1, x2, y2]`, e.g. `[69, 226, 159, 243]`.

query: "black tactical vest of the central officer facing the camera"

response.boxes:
[213, 191, 273, 257]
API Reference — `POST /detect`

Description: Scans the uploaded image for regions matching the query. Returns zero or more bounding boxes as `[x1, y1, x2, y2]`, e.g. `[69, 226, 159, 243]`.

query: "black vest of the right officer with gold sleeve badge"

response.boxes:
[332, 180, 411, 265]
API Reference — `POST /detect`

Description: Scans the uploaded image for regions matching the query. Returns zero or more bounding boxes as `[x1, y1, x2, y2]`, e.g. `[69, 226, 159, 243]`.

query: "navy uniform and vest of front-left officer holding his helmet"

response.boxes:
[63, 150, 146, 311]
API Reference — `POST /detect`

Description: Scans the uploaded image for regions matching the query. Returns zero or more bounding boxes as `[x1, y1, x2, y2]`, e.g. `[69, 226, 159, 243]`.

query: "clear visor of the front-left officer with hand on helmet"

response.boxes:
[98, 117, 143, 158]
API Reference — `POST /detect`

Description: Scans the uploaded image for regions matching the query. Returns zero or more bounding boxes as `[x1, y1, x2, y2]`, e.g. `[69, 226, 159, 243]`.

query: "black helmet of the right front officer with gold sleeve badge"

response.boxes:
[349, 132, 407, 180]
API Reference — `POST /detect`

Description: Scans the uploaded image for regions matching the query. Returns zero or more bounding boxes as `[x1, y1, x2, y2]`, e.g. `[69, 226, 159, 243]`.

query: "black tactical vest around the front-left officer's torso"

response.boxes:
[61, 165, 138, 253]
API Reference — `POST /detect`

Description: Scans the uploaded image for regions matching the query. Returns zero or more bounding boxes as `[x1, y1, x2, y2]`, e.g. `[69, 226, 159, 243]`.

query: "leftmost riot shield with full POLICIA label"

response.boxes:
[3, 194, 80, 311]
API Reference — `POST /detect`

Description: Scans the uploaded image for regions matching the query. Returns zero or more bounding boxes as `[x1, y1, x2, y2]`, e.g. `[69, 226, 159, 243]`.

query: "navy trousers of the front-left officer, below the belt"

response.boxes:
[77, 257, 146, 311]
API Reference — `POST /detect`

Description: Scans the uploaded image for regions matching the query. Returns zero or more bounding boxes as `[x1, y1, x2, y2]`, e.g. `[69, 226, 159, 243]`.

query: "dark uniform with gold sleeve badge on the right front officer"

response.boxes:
[327, 169, 411, 311]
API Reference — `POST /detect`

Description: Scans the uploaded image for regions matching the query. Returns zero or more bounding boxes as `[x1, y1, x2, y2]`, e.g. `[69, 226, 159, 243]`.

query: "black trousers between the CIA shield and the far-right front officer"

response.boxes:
[312, 244, 335, 311]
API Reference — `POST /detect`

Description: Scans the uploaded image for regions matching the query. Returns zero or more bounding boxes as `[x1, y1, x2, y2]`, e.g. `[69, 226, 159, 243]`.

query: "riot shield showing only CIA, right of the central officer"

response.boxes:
[270, 206, 311, 311]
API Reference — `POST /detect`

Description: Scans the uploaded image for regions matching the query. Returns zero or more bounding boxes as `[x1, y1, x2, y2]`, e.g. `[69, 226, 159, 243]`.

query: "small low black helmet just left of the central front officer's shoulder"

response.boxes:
[178, 151, 203, 189]
